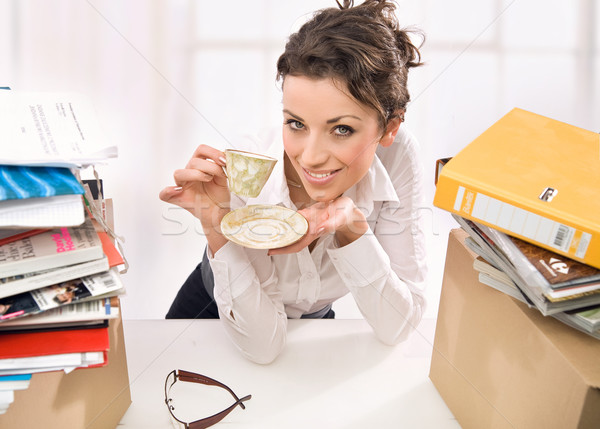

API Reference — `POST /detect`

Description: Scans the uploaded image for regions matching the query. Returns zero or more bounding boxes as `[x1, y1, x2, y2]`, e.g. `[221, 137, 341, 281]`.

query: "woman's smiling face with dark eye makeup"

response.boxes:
[283, 75, 395, 202]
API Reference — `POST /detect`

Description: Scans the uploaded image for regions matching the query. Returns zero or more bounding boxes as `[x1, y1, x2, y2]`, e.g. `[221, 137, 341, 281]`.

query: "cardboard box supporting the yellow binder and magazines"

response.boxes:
[429, 229, 600, 429]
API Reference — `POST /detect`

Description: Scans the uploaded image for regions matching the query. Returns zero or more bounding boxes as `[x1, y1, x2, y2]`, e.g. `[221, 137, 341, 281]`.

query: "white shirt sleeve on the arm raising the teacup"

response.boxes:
[208, 242, 287, 364]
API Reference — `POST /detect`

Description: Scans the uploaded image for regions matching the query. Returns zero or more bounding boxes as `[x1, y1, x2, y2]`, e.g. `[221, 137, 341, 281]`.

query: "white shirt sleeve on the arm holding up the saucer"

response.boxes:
[328, 130, 427, 344]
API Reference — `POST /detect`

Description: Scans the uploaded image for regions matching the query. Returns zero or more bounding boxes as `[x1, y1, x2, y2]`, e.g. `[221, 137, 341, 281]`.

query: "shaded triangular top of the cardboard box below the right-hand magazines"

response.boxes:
[515, 300, 600, 389]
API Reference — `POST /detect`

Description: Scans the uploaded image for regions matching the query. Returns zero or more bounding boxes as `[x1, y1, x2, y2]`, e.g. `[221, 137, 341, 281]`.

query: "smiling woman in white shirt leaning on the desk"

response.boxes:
[160, 0, 425, 363]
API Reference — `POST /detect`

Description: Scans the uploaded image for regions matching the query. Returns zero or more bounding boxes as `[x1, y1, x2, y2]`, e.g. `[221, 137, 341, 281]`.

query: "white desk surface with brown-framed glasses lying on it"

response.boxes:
[119, 320, 460, 429]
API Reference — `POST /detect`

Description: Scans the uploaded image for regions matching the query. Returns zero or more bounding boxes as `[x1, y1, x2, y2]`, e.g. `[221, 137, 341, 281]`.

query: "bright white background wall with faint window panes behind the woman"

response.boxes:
[0, 0, 600, 318]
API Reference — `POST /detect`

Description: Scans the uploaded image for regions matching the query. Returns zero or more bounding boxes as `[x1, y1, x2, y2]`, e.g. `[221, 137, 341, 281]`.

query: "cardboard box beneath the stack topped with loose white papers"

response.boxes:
[0, 318, 131, 429]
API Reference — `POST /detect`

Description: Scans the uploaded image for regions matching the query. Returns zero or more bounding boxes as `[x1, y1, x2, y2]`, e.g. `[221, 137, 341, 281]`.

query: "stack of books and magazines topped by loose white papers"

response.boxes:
[0, 91, 124, 414]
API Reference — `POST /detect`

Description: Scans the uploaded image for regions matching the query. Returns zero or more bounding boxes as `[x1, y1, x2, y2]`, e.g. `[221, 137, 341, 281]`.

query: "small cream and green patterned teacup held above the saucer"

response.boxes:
[225, 149, 277, 198]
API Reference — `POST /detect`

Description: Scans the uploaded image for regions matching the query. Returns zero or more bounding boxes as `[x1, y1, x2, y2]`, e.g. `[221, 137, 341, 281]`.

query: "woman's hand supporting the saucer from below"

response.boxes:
[269, 197, 369, 256]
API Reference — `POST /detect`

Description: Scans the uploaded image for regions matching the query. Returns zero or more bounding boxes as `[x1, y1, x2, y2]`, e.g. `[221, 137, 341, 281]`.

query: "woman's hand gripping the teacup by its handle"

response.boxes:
[159, 145, 230, 229]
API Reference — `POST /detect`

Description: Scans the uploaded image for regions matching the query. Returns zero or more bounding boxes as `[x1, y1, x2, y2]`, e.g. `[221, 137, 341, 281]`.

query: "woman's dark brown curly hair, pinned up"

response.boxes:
[277, 0, 424, 127]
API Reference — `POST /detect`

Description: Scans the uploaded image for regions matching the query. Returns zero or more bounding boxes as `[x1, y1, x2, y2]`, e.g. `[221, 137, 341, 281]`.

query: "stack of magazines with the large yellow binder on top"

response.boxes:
[434, 109, 600, 339]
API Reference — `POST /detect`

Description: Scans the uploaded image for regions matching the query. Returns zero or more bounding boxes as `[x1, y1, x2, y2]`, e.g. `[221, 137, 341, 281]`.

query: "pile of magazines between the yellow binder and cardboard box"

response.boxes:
[452, 214, 600, 339]
